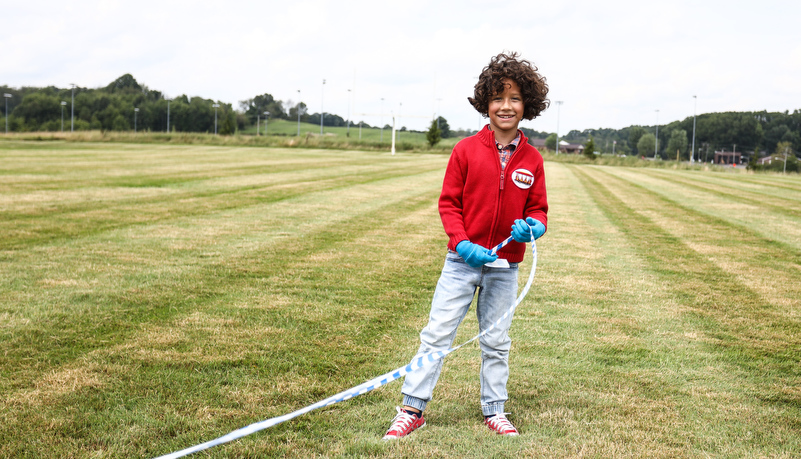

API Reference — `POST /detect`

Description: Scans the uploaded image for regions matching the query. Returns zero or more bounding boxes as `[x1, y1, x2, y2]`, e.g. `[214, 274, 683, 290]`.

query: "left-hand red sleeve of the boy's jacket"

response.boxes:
[439, 149, 469, 250]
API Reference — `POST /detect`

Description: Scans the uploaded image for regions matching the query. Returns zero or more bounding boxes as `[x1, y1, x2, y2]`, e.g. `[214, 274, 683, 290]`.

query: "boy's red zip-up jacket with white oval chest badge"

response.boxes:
[439, 127, 548, 263]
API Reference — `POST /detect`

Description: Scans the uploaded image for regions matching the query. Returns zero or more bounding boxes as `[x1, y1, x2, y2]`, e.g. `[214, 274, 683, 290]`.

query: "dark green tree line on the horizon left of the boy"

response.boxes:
[0, 74, 382, 135]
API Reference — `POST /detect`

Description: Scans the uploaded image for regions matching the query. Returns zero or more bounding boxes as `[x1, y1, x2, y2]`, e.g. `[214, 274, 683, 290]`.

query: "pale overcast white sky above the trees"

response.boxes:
[0, 0, 801, 135]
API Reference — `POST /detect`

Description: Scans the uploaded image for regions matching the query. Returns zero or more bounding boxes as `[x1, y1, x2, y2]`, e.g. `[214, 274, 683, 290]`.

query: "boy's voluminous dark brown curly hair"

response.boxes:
[467, 52, 550, 120]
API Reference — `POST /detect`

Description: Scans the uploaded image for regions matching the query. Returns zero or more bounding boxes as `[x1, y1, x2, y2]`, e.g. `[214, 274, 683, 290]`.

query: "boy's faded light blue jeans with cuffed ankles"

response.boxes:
[401, 251, 517, 416]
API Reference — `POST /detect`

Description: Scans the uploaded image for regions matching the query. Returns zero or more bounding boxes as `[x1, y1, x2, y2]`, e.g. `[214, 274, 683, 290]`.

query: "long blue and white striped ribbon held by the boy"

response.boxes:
[156, 234, 537, 459]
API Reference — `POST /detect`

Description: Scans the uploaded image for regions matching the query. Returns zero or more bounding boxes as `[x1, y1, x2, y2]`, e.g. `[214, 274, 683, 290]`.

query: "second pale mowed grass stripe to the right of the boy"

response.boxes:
[581, 168, 801, 360]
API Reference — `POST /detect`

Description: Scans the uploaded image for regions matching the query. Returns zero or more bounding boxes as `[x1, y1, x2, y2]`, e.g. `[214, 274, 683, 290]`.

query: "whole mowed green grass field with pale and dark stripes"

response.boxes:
[0, 141, 801, 458]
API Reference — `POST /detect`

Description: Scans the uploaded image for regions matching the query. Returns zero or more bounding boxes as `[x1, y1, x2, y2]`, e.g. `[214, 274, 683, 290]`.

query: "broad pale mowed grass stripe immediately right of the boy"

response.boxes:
[513, 164, 732, 457]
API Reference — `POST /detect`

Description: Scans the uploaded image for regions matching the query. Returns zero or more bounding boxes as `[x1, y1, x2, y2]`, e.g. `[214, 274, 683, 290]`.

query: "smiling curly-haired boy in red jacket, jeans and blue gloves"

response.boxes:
[383, 53, 548, 440]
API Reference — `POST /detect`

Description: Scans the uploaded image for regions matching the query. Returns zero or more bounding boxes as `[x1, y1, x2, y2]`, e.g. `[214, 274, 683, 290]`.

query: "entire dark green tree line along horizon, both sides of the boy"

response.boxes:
[0, 74, 801, 168]
